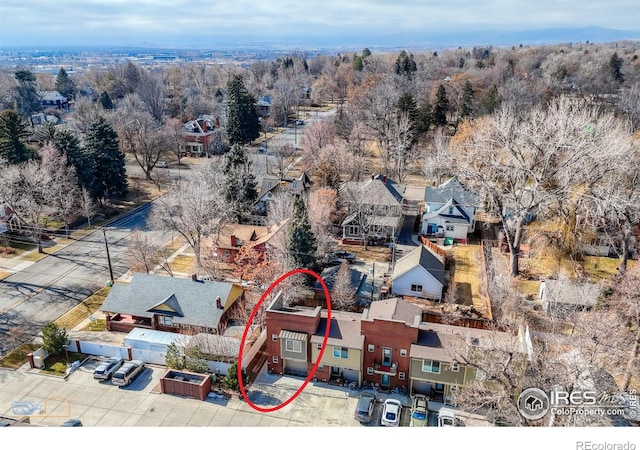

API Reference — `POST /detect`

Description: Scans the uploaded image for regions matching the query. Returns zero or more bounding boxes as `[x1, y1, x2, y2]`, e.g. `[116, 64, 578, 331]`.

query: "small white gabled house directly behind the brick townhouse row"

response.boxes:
[391, 245, 445, 300]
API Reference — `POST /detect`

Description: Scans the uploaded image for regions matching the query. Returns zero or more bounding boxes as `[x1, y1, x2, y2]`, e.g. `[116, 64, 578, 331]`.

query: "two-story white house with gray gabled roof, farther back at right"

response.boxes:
[422, 178, 479, 243]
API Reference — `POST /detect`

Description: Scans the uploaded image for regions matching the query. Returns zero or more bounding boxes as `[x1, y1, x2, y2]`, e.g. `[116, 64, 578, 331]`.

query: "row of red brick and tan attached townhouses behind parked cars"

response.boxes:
[266, 294, 519, 401]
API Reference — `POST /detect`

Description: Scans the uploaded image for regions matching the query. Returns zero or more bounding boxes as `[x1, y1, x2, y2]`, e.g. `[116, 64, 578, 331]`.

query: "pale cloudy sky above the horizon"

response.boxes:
[0, 0, 640, 46]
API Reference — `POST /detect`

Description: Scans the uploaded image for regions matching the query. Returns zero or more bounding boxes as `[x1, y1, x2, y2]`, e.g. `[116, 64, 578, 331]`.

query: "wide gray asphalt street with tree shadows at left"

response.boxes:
[0, 204, 159, 356]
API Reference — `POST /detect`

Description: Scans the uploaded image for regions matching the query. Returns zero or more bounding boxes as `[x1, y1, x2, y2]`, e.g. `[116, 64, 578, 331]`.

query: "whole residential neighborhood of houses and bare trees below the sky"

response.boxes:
[0, 9, 640, 440]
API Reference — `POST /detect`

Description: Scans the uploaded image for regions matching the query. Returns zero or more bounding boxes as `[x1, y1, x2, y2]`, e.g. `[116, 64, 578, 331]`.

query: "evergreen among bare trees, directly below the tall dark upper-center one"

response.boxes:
[223, 144, 258, 222]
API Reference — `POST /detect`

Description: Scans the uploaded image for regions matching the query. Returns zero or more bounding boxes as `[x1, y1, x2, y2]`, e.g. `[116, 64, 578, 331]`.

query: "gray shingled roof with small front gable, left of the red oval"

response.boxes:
[101, 273, 242, 328]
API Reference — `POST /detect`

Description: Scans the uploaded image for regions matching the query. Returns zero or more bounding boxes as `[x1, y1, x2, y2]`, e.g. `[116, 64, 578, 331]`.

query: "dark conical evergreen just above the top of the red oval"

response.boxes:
[287, 197, 317, 270]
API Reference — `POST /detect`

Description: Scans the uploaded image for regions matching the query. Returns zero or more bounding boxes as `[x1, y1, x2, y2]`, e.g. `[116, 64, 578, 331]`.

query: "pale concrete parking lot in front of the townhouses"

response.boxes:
[0, 360, 416, 427]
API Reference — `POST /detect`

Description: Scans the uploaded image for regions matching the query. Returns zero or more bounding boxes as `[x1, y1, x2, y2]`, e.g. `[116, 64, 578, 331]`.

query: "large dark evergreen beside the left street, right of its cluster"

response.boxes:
[85, 117, 127, 205]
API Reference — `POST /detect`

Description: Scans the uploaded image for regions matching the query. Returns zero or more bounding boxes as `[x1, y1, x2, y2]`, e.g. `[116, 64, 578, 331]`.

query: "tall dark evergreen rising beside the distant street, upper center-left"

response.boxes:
[227, 75, 260, 145]
